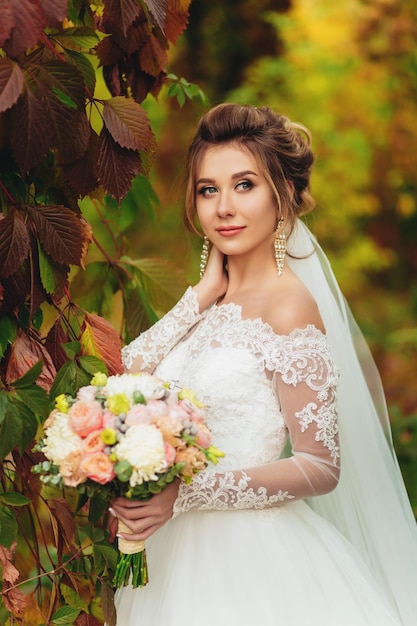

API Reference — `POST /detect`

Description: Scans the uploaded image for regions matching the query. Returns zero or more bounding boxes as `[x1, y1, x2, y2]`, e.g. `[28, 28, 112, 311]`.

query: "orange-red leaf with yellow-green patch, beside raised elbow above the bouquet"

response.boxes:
[81, 313, 123, 375]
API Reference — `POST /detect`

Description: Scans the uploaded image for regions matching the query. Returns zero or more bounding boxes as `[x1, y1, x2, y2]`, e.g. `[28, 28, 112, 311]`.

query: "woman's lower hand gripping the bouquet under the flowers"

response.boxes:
[109, 480, 179, 541]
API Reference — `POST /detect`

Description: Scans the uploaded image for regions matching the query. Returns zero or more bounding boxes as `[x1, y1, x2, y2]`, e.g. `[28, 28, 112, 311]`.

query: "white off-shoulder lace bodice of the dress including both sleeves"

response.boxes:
[123, 288, 339, 514]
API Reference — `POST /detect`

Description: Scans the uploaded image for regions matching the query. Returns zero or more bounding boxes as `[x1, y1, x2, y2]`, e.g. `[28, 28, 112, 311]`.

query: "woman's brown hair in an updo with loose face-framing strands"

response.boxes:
[183, 103, 315, 234]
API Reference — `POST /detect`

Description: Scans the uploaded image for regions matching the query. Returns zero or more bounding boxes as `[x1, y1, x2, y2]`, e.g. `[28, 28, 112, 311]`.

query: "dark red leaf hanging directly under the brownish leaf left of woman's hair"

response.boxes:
[96, 128, 142, 200]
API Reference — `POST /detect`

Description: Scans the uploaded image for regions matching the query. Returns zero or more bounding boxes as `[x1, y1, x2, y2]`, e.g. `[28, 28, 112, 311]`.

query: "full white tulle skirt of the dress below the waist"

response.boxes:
[116, 502, 400, 626]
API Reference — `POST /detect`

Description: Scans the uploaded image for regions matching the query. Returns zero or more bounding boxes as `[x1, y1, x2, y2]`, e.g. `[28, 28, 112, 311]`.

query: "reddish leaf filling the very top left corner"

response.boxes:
[0, 0, 47, 58]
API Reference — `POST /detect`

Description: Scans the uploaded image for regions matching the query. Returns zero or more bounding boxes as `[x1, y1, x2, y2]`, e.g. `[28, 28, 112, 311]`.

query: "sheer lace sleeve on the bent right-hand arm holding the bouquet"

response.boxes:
[174, 327, 339, 517]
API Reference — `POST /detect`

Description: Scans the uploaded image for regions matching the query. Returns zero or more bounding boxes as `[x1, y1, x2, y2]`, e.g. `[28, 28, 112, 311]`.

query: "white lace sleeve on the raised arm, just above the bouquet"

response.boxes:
[122, 287, 201, 373]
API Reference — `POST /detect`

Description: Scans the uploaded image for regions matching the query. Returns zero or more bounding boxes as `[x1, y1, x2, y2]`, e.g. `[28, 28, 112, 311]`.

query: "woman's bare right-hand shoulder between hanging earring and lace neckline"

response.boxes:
[264, 275, 324, 335]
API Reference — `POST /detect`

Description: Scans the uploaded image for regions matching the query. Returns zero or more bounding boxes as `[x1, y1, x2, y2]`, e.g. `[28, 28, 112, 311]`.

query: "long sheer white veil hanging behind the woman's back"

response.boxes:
[288, 220, 417, 626]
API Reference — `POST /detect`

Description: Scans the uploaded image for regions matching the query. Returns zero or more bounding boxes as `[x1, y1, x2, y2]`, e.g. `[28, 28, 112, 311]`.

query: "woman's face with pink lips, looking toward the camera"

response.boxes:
[196, 144, 278, 257]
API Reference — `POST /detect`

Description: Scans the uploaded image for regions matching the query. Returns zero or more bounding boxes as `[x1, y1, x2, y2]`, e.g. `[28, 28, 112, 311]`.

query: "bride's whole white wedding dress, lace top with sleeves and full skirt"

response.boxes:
[116, 219, 417, 626]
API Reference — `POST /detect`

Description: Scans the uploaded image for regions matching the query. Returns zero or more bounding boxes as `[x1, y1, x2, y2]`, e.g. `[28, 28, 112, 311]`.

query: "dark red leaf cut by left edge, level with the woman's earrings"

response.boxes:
[0, 211, 29, 278]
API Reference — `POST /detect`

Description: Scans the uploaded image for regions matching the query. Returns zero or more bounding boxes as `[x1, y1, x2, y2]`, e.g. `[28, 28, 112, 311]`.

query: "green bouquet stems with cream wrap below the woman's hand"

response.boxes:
[113, 520, 149, 589]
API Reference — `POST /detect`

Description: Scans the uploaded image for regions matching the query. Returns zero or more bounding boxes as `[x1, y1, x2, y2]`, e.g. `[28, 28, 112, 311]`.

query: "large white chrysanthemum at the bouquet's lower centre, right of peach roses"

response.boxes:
[113, 424, 166, 487]
